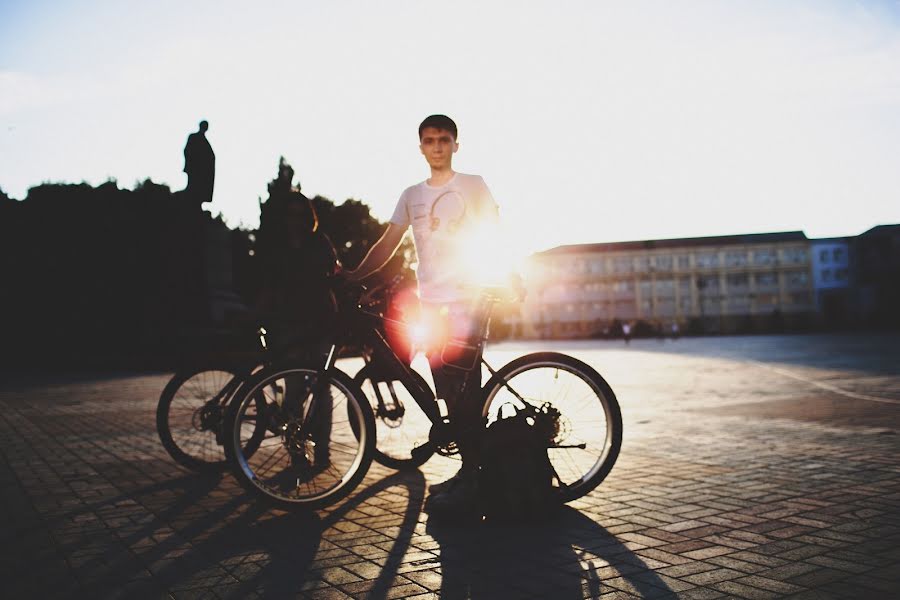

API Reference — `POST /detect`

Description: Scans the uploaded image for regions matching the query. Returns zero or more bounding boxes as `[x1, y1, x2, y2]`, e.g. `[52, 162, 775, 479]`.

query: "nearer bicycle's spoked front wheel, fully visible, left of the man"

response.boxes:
[225, 367, 375, 508]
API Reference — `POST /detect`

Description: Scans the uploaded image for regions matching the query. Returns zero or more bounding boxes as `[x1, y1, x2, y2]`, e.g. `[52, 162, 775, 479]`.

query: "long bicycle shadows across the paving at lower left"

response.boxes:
[60, 471, 425, 599]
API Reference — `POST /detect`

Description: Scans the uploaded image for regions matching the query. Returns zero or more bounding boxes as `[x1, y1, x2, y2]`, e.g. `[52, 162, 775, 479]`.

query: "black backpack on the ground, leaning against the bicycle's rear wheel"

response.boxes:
[478, 403, 559, 522]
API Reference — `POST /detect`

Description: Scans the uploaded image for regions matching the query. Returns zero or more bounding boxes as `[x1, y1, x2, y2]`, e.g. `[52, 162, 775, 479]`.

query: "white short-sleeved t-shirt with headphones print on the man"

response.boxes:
[391, 173, 498, 302]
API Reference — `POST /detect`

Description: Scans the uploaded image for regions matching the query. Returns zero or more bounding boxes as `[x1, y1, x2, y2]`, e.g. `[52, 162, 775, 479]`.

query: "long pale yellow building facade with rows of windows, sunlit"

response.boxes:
[511, 231, 816, 338]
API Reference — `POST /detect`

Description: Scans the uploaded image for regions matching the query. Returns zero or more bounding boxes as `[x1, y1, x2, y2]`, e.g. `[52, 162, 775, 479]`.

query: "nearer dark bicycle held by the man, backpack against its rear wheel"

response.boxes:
[225, 278, 622, 508]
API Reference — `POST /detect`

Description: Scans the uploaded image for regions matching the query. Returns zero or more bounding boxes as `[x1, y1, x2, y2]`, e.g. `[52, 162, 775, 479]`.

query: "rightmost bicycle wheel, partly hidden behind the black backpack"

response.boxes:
[482, 352, 622, 502]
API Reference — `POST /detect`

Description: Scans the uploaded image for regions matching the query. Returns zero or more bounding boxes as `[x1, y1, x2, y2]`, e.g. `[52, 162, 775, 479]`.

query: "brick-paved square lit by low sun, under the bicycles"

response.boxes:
[0, 336, 900, 599]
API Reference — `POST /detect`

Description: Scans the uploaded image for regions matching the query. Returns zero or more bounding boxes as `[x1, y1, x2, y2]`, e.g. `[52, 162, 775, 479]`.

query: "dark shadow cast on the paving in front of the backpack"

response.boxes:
[426, 506, 675, 600]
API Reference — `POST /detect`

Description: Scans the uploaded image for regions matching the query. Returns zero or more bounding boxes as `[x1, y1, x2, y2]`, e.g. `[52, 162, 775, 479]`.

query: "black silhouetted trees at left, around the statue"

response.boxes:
[0, 158, 413, 367]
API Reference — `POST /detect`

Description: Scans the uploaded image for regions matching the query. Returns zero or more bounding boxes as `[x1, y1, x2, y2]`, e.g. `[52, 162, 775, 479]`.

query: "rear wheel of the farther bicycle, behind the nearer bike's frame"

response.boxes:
[353, 364, 434, 470]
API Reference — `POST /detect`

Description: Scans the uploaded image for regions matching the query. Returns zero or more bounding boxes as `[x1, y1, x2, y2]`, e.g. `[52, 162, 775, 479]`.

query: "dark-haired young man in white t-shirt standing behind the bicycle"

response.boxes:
[347, 115, 498, 514]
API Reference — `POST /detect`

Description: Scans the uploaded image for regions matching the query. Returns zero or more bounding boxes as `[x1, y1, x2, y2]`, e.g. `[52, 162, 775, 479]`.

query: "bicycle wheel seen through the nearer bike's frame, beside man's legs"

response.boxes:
[353, 364, 434, 471]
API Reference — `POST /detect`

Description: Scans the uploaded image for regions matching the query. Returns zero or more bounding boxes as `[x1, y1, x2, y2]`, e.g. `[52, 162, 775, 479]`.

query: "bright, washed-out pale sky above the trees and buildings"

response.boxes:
[0, 0, 900, 251]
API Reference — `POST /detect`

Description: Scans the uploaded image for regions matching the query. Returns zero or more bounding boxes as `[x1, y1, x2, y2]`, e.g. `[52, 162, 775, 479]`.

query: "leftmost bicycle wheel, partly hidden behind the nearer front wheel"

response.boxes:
[156, 365, 243, 472]
